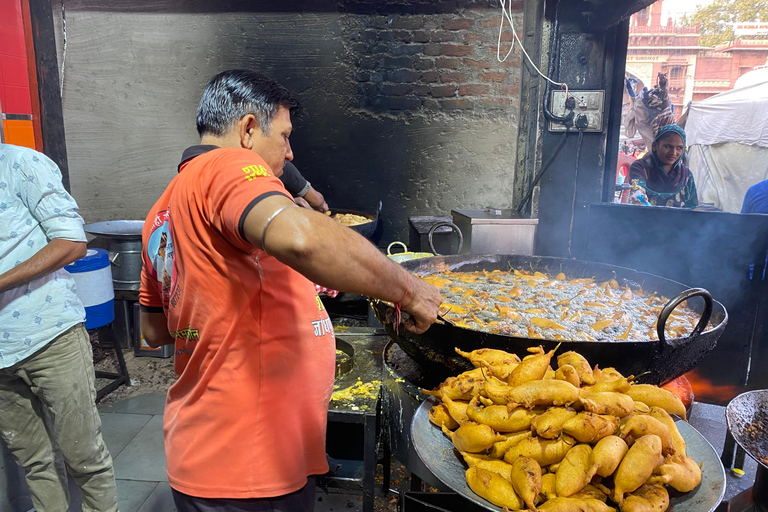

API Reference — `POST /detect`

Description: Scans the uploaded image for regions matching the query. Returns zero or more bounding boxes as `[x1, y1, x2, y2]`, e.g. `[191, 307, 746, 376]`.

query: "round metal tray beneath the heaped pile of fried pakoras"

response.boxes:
[411, 397, 725, 512]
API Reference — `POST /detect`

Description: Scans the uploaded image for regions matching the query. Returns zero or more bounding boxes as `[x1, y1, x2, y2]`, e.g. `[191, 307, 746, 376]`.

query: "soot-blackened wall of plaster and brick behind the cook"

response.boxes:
[53, 0, 523, 243]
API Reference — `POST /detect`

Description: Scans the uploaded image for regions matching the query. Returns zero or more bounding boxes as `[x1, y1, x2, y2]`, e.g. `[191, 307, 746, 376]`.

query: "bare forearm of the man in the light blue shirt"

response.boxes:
[0, 238, 88, 293]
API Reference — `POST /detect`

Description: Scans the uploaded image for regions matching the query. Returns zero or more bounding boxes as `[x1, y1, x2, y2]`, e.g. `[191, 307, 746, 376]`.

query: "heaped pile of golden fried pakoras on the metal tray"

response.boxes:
[423, 347, 701, 512]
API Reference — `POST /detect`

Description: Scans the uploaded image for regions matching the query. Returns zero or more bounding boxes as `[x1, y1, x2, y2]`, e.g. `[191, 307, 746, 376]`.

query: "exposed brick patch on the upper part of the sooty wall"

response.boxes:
[342, 0, 523, 116]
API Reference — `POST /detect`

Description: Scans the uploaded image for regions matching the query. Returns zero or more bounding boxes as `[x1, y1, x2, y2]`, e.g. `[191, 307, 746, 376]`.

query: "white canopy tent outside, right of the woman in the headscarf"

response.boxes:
[685, 69, 768, 213]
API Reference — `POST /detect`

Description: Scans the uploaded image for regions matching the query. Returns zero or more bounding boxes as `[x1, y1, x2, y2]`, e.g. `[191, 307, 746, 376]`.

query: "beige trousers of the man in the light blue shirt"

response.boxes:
[0, 324, 117, 512]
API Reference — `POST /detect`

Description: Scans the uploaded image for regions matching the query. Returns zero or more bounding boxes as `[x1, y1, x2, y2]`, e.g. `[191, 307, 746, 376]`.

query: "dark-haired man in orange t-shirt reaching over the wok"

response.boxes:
[140, 70, 441, 512]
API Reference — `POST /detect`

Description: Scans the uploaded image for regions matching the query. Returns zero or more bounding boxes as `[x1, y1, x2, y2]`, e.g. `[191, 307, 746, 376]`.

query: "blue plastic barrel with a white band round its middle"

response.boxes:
[64, 249, 115, 329]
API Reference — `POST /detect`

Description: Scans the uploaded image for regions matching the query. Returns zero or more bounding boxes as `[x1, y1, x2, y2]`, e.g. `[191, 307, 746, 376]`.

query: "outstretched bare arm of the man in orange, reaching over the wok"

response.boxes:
[243, 196, 442, 333]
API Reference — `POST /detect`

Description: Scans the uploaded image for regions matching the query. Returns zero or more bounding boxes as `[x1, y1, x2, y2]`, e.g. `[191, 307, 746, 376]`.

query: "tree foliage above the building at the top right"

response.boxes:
[681, 0, 768, 46]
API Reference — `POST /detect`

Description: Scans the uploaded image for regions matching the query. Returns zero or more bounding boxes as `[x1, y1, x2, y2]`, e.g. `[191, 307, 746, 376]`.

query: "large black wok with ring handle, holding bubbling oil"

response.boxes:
[371, 255, 728, 384]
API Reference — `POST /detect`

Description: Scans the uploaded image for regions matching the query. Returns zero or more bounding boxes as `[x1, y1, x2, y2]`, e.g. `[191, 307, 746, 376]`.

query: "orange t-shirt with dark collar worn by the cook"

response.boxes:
[140, 146, 336, 498]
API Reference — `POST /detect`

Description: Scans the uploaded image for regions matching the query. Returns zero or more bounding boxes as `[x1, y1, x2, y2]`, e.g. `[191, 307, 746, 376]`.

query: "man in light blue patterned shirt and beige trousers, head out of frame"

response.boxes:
[0, 144, 117, 512]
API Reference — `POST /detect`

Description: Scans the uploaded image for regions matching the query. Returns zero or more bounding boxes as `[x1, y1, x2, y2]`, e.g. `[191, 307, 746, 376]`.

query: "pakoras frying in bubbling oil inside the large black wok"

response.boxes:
[422, 269, 699, 341]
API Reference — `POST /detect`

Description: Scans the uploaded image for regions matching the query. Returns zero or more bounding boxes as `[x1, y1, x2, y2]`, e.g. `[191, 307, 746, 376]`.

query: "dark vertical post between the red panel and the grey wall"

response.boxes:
[21, 0, 69, 191]
